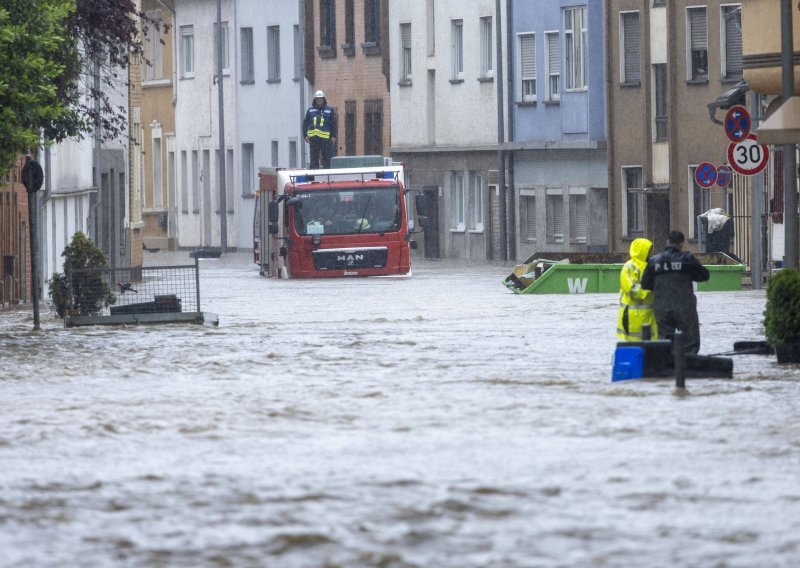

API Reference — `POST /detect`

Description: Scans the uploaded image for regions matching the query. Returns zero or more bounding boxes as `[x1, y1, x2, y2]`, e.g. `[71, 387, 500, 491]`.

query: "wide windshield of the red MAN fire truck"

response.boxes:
[292, 185, 400, 235]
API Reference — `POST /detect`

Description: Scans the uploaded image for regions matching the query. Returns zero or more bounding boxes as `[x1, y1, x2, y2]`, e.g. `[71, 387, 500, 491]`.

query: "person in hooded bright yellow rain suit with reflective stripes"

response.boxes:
[617, 239, 658, 341]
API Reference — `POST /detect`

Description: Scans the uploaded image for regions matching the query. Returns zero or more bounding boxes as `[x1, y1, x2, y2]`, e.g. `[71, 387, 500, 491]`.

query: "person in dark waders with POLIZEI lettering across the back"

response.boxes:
[642, 231, 709, 354]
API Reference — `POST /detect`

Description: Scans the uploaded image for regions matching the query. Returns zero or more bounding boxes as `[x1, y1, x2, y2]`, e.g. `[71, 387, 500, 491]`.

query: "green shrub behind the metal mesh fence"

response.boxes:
[48, 232, 117, 318]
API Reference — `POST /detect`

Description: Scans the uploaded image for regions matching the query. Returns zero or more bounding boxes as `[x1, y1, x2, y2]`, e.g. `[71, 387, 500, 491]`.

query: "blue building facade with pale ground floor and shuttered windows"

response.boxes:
[504, 0, 608, 260]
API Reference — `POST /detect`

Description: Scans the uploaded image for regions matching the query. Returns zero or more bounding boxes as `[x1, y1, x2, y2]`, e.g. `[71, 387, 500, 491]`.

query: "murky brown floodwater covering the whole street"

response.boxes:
[0, 252, 800, 568]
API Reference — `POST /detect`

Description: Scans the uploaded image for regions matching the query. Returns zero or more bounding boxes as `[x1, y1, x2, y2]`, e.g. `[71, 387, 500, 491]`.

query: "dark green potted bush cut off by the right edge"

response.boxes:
[764, 269, 800, 363]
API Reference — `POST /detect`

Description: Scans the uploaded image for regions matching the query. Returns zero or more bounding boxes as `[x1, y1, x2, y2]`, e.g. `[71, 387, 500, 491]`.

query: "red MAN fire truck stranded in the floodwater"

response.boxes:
[253, 156, 426, 278]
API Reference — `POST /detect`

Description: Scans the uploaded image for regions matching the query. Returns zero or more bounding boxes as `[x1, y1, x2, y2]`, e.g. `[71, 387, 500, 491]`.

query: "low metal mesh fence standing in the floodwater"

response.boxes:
[65, 259, 200, 316]
